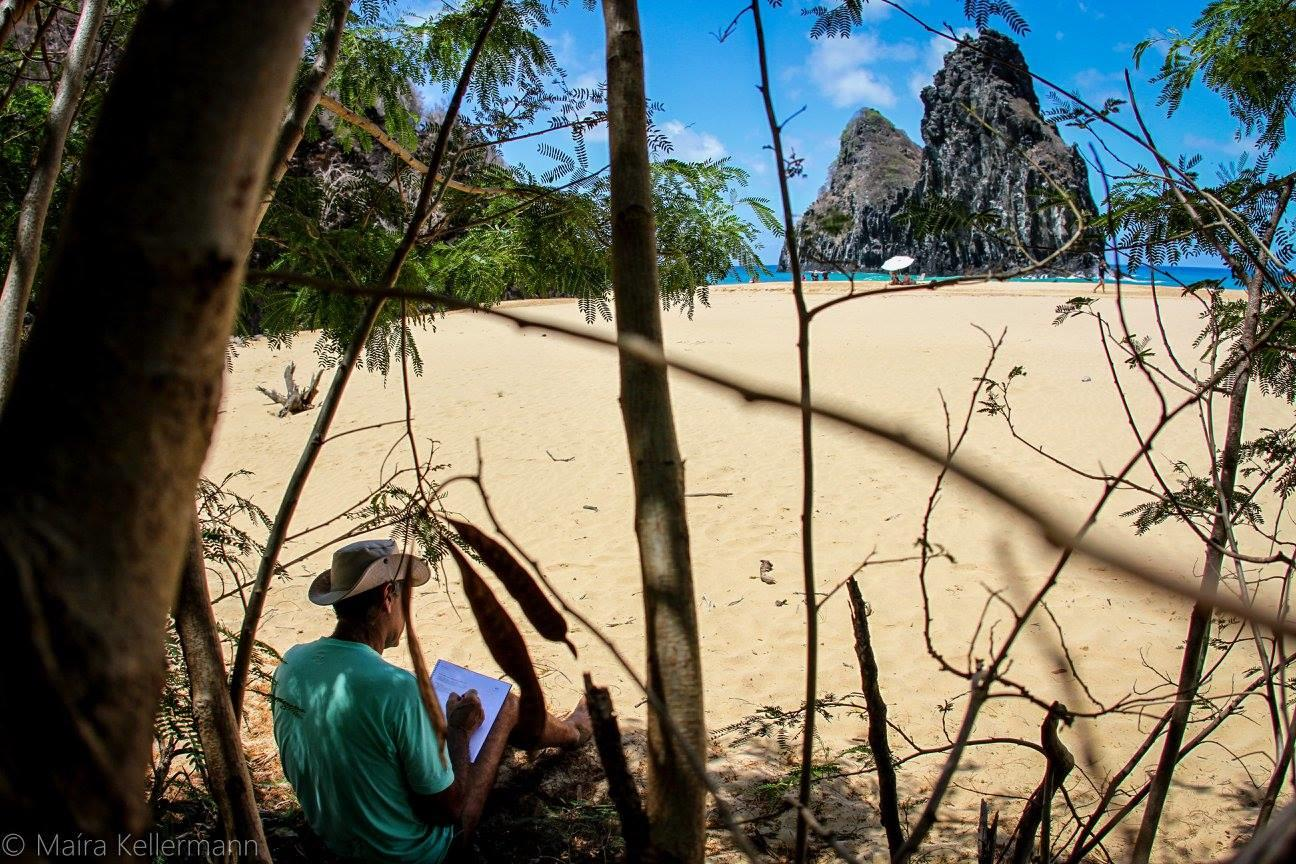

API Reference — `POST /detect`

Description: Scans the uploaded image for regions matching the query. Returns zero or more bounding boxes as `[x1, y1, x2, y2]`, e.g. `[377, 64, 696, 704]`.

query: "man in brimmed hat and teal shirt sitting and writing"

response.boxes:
[272, 540, 591, 863]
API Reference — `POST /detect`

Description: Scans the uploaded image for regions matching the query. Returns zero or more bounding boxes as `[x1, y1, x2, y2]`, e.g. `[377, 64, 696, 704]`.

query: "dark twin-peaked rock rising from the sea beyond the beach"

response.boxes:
[802, 31, 1100, 275]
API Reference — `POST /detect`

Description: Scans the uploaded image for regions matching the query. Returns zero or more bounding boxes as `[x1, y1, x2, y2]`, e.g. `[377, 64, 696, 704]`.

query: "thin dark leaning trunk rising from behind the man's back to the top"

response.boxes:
[229, 0, 504, 718]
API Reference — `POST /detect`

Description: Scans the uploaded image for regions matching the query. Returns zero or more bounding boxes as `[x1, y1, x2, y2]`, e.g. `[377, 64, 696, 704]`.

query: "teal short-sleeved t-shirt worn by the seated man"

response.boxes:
[272, 639, 455, 861]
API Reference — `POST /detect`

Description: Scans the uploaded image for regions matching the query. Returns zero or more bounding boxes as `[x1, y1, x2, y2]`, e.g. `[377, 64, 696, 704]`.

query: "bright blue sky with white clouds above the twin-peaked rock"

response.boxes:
[419, 0, 1270, 263]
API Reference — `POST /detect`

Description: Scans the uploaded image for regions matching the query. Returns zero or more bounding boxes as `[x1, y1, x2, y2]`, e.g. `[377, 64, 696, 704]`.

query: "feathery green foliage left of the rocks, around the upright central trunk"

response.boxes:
[241, 0, 776, 373]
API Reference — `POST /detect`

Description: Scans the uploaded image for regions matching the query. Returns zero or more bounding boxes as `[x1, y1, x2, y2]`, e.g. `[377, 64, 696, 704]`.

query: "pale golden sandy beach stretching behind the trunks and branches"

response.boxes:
[203, 282, 1291, 861]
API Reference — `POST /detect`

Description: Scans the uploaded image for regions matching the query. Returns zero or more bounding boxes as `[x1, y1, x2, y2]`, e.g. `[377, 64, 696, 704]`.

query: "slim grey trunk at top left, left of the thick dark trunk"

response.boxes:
[0, 0, 108, 411]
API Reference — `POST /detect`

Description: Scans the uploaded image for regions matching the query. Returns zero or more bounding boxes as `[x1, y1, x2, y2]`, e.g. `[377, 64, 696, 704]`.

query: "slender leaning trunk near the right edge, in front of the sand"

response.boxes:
[1130, 273, 1264, 864]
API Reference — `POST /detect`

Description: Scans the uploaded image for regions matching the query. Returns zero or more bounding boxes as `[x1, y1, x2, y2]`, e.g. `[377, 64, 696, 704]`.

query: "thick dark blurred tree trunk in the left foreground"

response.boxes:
[0, 0, 318, 839]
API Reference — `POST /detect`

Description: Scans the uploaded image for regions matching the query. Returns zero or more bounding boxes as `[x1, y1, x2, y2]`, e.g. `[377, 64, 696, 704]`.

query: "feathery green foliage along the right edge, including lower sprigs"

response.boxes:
[1078, 0, 1296, 564]
